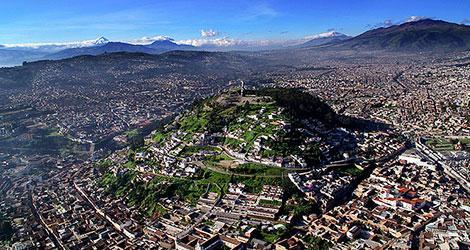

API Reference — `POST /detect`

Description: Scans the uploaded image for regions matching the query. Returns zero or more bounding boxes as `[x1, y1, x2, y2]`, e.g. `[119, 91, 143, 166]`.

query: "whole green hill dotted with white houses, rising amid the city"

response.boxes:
[96, 89, 338, 213]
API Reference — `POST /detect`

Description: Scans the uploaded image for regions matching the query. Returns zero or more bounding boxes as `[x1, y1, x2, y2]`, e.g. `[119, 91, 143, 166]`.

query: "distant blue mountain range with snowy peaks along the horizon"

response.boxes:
[0, 19, 470, 66]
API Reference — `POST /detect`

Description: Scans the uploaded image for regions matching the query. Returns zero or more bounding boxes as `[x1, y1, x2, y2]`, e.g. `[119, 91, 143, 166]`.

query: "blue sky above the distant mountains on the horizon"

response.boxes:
[0, 0, 470, 44]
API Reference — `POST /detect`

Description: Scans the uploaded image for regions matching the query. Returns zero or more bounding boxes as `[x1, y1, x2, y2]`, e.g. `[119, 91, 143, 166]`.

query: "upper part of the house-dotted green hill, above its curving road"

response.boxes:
[158, 88, 337, 168]
